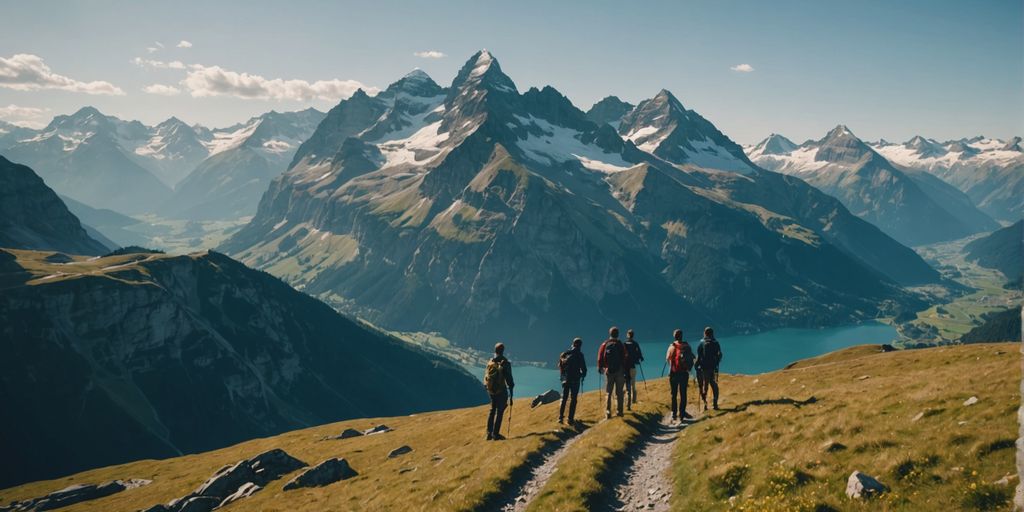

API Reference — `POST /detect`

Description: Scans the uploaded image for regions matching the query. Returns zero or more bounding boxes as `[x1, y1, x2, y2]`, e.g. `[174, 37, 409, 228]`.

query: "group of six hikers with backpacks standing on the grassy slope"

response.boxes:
[483, 327, 722, 440]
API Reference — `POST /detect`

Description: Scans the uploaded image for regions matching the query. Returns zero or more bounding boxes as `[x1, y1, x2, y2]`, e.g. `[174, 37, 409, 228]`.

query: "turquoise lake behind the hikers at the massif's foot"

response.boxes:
[467, 322, 897, 397]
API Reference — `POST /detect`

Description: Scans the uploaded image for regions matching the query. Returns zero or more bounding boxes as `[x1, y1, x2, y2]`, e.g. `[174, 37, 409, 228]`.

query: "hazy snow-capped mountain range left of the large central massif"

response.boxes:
[0, 106, 324, 219]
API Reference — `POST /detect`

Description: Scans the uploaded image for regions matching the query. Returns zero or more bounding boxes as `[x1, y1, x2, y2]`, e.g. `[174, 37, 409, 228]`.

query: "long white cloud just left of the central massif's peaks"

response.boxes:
[181, 65, 380, 101]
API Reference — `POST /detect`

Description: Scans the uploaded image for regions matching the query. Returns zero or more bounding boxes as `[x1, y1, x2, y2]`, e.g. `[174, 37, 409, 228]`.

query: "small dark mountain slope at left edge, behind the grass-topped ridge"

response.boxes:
[0, 157, 111, 255]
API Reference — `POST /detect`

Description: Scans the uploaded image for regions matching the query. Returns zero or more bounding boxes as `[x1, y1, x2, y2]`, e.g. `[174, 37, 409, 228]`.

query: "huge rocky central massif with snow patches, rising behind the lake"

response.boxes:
[222, 51, 939, 357]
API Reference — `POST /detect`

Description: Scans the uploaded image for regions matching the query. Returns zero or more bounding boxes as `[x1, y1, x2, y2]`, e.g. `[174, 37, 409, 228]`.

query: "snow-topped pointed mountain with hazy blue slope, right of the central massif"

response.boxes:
[749, 125, 998, 246]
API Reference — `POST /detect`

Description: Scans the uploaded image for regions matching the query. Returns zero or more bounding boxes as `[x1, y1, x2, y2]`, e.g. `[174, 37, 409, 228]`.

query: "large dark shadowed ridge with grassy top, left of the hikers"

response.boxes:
[0, 250, 483, 487]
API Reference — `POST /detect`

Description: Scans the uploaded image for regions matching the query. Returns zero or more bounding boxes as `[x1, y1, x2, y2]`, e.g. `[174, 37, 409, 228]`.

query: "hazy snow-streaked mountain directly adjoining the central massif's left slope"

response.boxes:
[160, 109, 325, 219]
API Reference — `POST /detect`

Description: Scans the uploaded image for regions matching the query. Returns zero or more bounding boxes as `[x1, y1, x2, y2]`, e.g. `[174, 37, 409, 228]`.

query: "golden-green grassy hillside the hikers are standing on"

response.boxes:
[0, 344, 1021, 511]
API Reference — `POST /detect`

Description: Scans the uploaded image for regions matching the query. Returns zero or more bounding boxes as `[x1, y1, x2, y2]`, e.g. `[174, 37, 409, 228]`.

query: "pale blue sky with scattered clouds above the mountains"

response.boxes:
[0, 0, 1024, 143]
